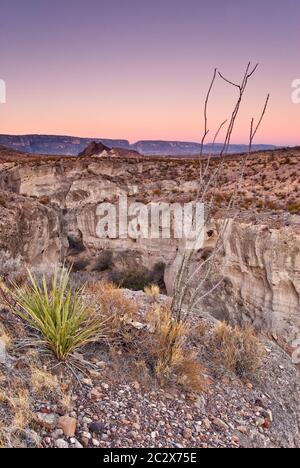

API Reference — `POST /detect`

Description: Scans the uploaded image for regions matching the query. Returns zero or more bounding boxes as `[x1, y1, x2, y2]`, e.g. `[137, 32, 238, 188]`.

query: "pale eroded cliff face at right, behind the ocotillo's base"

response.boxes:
[165, 220, 300, 343]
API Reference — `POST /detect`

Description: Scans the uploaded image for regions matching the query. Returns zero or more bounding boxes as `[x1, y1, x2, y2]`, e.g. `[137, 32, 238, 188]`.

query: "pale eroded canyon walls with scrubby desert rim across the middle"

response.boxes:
[0, 144, 300, 349]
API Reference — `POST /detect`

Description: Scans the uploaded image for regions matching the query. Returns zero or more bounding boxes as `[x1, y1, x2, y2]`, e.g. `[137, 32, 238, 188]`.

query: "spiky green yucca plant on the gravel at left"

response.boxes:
[9, 268, 105, 361]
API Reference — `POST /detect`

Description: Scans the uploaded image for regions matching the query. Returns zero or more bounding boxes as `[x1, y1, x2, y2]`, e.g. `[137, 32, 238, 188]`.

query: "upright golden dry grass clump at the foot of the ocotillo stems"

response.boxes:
[143, 306, 206, 391]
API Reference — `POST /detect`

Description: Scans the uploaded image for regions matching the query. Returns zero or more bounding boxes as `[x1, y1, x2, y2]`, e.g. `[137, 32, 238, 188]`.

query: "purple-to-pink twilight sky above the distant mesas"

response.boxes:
[0, 0, 300, 145]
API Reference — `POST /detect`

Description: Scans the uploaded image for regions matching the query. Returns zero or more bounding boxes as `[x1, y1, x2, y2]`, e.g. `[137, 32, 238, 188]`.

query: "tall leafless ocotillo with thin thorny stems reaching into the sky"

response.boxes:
[172, 62, 270, 321]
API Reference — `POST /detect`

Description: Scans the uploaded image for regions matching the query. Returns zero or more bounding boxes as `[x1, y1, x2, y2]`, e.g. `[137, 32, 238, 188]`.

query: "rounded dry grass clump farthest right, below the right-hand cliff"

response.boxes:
[211, 322, 263, 378]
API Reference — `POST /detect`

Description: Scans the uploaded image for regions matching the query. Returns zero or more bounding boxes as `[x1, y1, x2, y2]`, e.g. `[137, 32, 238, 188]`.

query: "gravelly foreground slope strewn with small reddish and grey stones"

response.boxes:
[0, 290, 300, 449]
